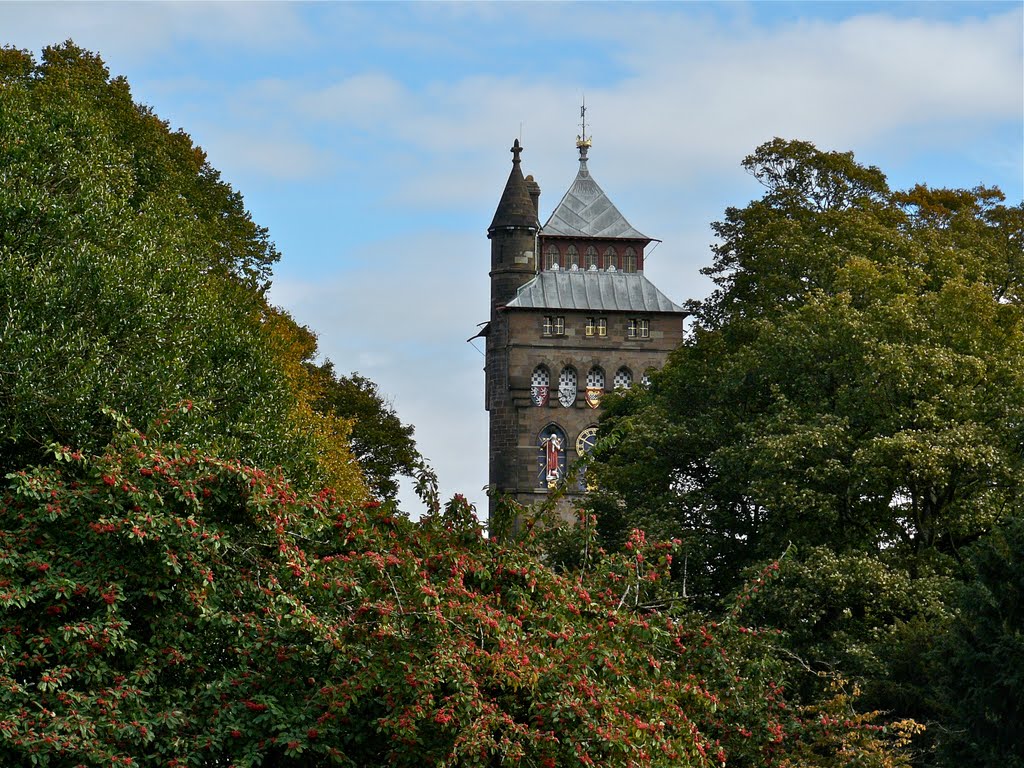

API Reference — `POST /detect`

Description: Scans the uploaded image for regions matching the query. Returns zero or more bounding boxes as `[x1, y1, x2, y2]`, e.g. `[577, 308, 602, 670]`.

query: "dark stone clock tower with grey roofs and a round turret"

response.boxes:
[479, 138, 686, 528]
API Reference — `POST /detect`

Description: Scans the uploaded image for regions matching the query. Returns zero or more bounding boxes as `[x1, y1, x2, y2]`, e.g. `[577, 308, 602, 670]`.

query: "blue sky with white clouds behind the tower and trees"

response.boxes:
[0, 0, 1024, 516]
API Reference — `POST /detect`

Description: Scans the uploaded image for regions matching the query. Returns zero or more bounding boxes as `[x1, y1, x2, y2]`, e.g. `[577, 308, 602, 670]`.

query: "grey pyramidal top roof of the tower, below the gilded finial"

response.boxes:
[541, 140, 650, 241]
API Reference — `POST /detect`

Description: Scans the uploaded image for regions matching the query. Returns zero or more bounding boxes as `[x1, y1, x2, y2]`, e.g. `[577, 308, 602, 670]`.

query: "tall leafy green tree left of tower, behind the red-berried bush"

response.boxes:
[0, 42, 362, 499]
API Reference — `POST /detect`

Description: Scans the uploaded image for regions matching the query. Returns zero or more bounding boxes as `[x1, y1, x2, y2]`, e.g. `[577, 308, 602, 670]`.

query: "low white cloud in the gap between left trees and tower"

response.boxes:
[270, 228, 489, 518]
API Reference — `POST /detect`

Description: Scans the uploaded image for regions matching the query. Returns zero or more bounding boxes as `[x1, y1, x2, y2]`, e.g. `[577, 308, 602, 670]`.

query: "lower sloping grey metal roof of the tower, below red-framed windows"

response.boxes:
[507, 269, 686, 313]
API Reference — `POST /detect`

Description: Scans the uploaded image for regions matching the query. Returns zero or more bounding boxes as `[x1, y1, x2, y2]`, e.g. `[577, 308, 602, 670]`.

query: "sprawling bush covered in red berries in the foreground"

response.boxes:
[0, 423, 904, 768]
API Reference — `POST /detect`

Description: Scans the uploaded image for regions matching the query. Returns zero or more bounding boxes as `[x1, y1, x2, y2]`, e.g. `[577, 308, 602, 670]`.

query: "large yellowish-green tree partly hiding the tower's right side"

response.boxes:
[591, 139, 1024, 757]
